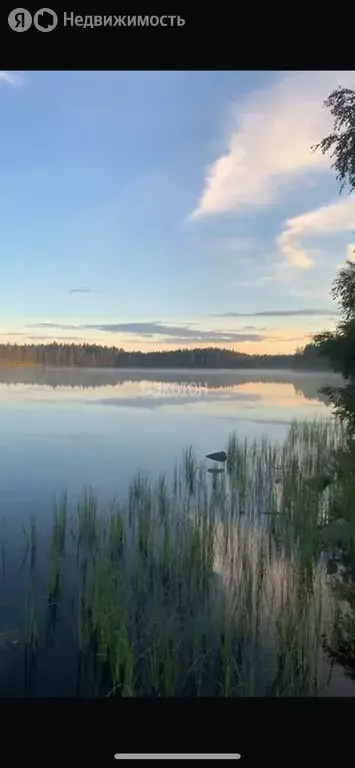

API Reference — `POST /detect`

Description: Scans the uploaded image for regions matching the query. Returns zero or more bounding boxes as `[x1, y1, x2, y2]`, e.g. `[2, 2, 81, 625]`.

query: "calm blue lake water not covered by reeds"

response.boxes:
[0, 368, 354, 696]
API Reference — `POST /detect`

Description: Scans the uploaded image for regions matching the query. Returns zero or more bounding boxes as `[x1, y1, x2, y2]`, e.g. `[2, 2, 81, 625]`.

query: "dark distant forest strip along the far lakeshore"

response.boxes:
[0, 342, 330, 371]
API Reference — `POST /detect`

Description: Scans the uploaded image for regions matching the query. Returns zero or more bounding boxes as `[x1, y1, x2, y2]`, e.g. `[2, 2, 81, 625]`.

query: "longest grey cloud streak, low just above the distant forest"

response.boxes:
[27, 322, 264, 343]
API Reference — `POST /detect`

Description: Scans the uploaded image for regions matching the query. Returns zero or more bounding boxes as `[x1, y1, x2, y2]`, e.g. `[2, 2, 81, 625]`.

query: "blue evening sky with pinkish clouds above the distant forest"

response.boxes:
[0, 71, 355, 354]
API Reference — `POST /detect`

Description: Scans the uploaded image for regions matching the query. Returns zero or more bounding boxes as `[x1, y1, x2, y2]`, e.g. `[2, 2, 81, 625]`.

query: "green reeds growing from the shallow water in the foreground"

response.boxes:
[4, 421, 354, 697]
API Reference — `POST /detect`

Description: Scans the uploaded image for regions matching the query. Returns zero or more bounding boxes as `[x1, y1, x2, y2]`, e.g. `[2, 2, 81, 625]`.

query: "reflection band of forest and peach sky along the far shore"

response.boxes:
[0, 368, 339, 425]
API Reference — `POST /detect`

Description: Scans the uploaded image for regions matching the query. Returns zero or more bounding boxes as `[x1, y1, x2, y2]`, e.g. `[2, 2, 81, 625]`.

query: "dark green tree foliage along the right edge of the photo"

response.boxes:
[314, 88, 355, 679]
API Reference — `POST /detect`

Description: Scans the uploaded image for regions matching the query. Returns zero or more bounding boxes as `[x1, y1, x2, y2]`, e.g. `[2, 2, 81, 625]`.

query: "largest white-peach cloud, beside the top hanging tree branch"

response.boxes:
[189, 72, 355, 220]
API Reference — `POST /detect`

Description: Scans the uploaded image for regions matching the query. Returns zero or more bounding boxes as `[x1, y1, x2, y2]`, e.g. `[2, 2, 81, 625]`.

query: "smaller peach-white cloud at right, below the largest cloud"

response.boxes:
[276, 196, 355, 270]
